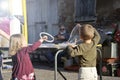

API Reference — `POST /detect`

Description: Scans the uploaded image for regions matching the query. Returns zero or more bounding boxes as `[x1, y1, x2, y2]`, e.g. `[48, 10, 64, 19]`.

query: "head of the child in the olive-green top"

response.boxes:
[80, 24, 94, 41]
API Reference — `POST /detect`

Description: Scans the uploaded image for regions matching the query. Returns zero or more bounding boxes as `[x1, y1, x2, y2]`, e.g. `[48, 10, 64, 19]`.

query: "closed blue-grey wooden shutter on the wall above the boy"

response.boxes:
[75, 0, 96, 22]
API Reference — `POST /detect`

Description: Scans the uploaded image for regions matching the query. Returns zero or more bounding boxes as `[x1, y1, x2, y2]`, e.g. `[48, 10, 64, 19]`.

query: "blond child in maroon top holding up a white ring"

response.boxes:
[9, 34, 47, 80]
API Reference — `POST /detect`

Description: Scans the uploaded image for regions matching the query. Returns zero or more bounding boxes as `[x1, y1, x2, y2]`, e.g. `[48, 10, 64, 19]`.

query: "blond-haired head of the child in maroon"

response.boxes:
[9, 34, 26, 55]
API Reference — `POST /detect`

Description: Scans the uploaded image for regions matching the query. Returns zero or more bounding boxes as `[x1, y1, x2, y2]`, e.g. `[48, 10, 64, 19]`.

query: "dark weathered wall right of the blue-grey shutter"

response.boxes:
[96, 0, 120, 28]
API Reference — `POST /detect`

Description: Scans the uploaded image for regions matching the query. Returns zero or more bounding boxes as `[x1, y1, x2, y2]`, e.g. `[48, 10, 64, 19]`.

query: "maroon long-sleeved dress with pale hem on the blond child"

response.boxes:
[12, 41, 41, 80]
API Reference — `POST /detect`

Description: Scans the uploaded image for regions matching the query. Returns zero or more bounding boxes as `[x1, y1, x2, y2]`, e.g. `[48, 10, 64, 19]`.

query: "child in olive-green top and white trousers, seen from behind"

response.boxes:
[66, 24, 100, 80]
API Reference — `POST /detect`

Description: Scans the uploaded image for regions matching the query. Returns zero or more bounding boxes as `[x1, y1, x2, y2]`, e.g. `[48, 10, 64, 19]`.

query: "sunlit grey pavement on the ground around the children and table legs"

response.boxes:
[2, 62, 120, 80]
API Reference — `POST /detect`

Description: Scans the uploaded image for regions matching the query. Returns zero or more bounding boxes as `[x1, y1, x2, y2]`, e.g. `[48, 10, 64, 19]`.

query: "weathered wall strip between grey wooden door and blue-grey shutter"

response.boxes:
[58, 0, 75, 30]
